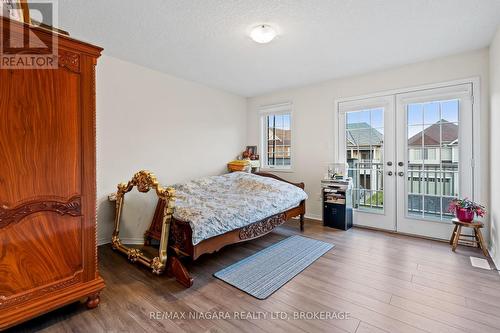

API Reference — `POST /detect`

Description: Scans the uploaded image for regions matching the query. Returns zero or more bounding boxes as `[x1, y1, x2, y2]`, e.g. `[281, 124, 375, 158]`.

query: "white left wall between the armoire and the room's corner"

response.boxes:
[97, 56, 246, 244]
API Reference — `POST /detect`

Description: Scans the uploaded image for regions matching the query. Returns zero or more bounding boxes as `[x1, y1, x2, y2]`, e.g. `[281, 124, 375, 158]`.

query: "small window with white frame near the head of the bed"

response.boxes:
[261, 103, 292, 170]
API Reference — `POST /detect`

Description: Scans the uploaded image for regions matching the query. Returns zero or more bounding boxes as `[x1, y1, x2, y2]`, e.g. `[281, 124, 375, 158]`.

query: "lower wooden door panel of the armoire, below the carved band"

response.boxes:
[0, 212, 82, 298]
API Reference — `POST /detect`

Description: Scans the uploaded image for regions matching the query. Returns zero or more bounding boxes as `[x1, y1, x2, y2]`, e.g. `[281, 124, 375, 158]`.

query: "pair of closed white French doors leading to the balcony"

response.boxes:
[339, 84, 474, 239]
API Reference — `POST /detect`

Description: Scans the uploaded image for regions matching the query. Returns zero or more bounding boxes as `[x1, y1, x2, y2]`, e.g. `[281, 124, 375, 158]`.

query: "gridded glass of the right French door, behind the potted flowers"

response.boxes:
[406, 100, 459, 220]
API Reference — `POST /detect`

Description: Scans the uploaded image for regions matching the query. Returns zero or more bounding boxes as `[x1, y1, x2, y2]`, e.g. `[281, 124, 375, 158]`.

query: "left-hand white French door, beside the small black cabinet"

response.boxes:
[339, 96, 396, 230]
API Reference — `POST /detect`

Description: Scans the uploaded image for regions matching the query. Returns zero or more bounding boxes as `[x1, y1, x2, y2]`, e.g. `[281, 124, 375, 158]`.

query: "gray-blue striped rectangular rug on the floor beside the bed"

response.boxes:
[214, 236, 334, 299]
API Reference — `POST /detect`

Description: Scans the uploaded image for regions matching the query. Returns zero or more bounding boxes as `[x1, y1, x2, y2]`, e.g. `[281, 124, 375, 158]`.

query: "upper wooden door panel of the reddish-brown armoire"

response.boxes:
[0, 70, 82, 208]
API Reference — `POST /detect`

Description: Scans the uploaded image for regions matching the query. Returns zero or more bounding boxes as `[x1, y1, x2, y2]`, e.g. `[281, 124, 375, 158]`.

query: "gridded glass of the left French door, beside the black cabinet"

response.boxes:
[345, 108, 384, 211]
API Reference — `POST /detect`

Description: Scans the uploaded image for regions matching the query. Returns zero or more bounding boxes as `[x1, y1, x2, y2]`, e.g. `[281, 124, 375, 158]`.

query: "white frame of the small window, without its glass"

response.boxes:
[259, 102, 295, 172]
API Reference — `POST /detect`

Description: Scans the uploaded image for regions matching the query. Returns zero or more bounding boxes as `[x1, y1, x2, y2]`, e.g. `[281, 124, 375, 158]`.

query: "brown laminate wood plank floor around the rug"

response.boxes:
[11, 220, 500, 333]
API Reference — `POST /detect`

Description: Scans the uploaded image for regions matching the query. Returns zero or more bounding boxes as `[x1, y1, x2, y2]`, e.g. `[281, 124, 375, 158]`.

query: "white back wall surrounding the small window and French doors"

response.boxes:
[247, 49, 489, 237]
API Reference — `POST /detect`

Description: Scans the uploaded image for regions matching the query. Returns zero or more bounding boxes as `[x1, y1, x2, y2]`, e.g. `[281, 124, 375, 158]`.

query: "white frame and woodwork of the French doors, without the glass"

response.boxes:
[334, 77, 481, 239]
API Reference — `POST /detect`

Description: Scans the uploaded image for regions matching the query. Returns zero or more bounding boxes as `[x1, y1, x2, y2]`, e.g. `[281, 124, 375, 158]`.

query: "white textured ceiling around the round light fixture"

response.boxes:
[58, 0, 500, 96]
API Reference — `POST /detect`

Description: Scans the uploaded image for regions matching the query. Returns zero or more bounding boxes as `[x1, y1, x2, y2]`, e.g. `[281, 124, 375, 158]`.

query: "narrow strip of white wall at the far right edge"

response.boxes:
[490, 27, 500, 268]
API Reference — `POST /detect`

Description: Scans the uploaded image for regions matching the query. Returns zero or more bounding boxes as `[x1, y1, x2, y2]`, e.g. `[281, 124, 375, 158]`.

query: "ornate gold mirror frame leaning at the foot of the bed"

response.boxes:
[111, 170, 175, 274]
